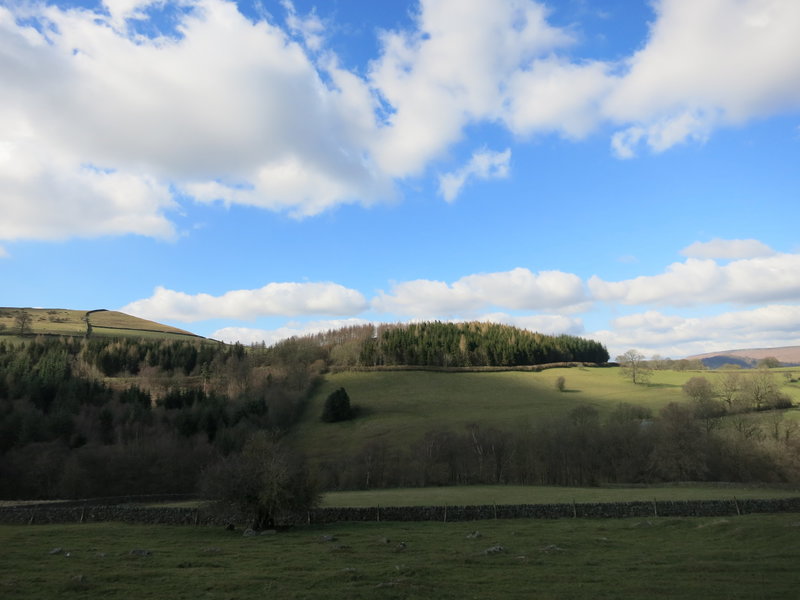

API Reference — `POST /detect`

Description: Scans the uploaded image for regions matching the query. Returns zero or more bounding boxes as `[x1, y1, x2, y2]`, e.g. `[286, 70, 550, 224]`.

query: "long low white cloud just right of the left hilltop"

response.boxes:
[121, 283, 367, 322]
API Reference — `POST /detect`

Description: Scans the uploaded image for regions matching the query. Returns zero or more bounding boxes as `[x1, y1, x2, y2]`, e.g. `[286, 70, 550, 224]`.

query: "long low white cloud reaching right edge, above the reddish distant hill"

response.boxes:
[588, 254, 800, 306]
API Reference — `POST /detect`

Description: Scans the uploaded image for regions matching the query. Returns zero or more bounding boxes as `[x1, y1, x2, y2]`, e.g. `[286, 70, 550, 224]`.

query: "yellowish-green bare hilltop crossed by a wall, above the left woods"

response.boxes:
[0, 307, 205, 339]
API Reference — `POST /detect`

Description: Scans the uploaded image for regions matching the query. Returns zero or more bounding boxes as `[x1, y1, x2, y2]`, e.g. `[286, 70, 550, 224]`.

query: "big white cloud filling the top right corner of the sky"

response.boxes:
[603, 0, 800, 158]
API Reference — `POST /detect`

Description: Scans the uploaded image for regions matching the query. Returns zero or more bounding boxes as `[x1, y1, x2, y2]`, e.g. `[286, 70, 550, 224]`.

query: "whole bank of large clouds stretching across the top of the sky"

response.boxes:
[0, 0, 800, 245]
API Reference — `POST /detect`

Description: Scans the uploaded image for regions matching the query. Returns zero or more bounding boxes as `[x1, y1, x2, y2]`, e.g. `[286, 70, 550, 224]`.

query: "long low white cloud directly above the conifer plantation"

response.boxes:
[372, 268, 586, 317]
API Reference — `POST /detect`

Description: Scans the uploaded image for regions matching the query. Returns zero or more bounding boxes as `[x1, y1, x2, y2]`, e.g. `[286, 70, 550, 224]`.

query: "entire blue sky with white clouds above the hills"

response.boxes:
[0, 0, 800, 358]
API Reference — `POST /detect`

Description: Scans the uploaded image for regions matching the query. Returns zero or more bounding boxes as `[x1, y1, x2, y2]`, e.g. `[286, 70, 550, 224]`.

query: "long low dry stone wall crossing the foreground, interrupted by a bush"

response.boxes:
[0, 497, 800, 525]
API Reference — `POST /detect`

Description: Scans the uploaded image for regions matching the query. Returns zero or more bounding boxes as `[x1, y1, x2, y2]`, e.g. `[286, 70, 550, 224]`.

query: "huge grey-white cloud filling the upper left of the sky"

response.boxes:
[0, 0, 392, 239]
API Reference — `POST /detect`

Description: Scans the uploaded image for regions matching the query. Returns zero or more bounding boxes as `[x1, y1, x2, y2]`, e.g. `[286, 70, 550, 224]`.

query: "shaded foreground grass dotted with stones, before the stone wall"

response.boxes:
[0, 514, 800, 600]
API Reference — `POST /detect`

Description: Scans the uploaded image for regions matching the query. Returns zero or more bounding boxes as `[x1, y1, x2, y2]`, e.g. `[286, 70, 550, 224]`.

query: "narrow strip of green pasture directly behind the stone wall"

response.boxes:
[322, 484, 800, 507]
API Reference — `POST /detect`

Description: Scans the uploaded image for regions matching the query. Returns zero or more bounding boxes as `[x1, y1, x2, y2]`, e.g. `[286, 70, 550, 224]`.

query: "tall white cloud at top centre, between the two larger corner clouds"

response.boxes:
[369, 0, 573, 177]
